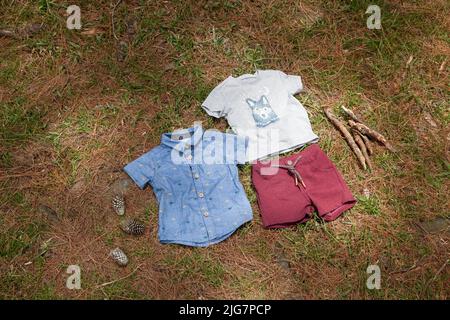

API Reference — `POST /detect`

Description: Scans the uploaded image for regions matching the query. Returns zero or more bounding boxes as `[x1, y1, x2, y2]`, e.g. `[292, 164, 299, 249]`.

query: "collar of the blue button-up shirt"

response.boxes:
[161, 123, 203, 151]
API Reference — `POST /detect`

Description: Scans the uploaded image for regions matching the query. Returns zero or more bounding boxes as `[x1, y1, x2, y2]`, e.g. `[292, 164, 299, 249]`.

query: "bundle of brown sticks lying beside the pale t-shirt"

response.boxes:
[324, 106, 396, 170]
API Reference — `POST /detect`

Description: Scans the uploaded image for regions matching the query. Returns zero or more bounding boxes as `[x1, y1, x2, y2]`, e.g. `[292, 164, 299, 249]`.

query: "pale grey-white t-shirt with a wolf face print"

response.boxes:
[202, 70, 319, 161]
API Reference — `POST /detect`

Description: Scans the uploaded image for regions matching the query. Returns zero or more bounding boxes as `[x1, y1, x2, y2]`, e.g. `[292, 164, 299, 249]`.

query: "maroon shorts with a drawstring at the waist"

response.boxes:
[252, 144, 356, 228]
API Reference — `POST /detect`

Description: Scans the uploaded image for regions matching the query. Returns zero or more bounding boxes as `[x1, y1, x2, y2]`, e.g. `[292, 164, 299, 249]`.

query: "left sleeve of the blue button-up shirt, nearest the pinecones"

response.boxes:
[123, 151, 155, 189]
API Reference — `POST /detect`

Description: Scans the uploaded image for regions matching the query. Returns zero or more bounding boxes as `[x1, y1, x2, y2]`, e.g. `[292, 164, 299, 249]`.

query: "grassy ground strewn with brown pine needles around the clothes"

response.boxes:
[0, 0, 450, 299]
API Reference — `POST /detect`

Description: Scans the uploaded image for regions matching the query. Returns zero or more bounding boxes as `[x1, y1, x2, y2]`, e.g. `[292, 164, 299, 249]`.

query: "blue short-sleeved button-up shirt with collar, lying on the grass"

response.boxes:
[124, 124, 253, 247]
